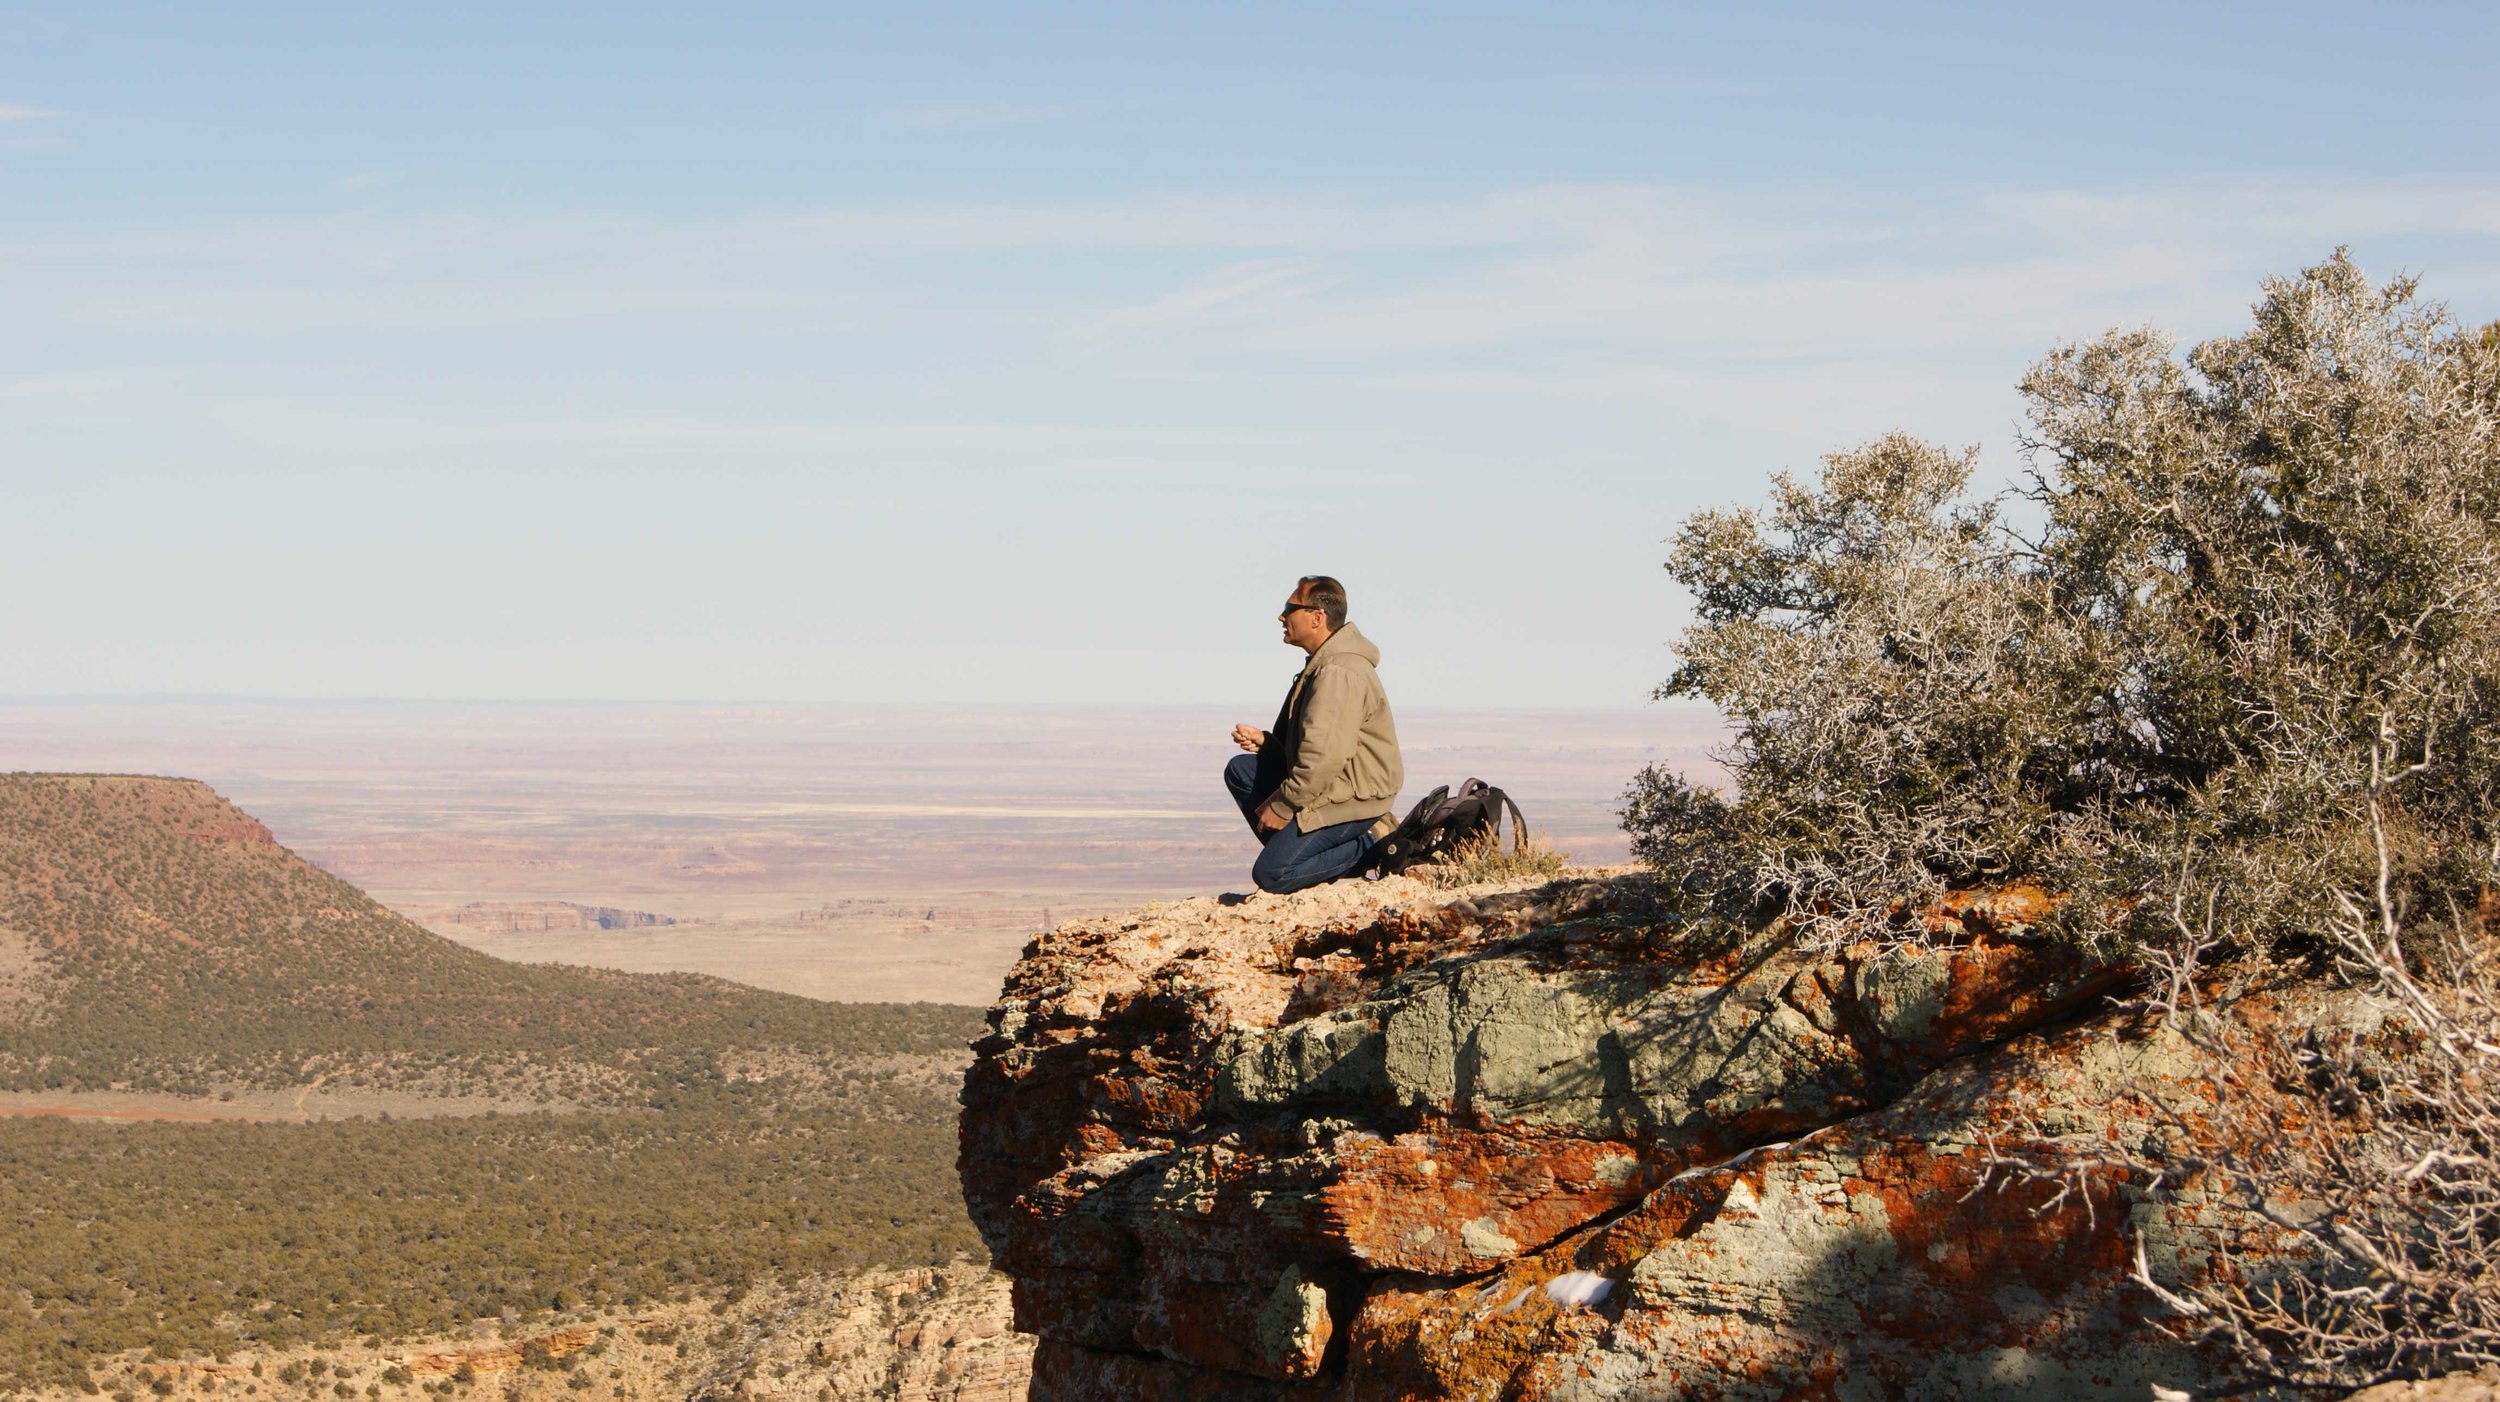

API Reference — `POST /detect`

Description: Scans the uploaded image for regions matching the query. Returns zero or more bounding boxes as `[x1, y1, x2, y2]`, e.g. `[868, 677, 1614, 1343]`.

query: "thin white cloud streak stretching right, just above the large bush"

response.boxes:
[1030, 185, 2500, 377]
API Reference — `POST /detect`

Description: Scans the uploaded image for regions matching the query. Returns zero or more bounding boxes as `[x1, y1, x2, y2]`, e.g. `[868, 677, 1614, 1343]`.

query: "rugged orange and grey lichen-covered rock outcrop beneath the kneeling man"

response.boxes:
[960, 877, 2300, 1402]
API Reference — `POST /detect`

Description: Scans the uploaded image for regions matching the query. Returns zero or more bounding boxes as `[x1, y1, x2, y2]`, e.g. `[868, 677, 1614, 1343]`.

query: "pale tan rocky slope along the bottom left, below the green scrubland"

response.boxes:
[58, 1262, 1033, 1402]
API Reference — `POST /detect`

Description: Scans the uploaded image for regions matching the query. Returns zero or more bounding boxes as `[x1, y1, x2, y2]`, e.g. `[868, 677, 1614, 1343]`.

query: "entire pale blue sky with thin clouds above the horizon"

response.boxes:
[0, 0, 2500, 699]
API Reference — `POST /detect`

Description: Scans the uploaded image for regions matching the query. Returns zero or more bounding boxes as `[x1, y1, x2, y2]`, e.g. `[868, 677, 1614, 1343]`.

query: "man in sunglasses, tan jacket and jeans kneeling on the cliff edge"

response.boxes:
[1225, 575, 1405, 892]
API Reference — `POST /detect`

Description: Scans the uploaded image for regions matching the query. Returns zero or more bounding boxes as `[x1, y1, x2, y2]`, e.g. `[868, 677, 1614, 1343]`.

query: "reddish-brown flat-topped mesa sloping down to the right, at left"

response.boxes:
[0, 775, 978, 1102]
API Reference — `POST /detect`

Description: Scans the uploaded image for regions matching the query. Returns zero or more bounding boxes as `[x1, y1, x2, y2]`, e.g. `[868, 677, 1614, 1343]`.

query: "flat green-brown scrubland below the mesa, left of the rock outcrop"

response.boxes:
[0, 1105, 980, 1385]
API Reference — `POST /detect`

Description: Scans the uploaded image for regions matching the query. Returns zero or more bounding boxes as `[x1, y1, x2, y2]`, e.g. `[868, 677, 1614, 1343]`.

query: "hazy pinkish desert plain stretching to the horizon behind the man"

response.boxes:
[0, 697, 1720, 1005]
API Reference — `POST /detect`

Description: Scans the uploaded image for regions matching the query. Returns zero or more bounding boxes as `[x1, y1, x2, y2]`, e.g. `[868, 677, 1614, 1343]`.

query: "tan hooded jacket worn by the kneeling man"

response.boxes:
[1273, 622, 1405, 832]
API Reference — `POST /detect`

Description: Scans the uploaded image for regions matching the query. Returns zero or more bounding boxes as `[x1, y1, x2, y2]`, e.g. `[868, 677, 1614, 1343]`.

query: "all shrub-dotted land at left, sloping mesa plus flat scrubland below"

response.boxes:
[0, 775, 980, 1390]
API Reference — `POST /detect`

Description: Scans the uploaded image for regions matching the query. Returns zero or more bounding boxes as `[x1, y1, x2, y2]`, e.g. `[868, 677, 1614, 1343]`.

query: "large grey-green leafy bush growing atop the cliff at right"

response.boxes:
[1625, 252, 2500, 960]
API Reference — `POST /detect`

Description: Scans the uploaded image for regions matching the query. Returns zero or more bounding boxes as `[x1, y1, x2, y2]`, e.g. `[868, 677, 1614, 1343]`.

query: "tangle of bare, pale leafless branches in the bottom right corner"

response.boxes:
[1990, 839, 2500, 1397]
